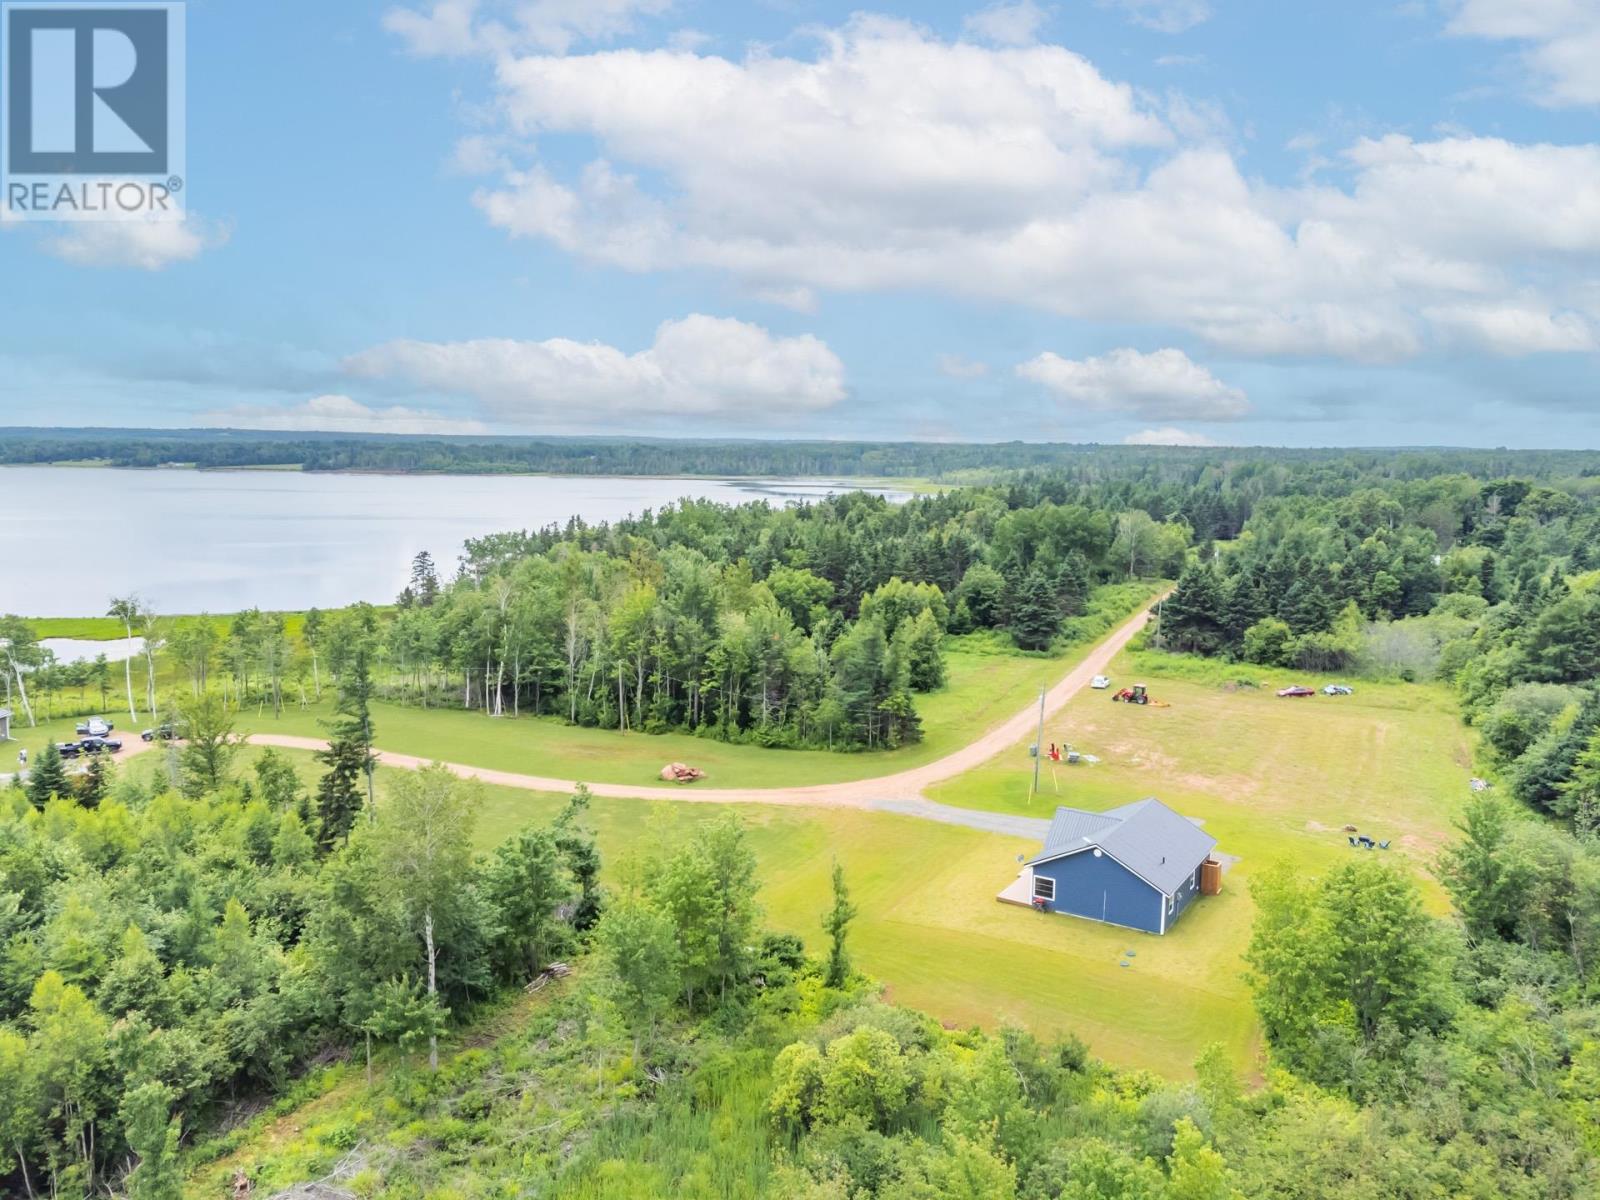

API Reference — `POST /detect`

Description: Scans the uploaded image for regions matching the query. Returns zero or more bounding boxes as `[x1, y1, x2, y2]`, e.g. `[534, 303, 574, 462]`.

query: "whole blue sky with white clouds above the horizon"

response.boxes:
[0, 0, 1600, 446]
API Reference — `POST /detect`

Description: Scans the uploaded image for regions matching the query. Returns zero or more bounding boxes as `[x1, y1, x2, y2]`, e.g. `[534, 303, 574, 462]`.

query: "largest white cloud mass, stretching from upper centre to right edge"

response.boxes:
[460, 16, 1600, 362]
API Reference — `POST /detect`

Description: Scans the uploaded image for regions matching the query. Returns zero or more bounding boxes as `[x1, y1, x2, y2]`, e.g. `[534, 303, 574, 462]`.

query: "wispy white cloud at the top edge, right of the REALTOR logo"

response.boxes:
[384, 0, 672, 58]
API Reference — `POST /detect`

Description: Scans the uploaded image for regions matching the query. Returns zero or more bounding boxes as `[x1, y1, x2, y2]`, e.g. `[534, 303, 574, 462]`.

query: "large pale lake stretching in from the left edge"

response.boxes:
[0, 467, 904, 616]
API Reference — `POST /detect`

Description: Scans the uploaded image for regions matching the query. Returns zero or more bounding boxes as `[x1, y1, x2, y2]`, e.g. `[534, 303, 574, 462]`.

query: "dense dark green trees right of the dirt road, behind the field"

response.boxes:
[1162, 477, 1600, 829]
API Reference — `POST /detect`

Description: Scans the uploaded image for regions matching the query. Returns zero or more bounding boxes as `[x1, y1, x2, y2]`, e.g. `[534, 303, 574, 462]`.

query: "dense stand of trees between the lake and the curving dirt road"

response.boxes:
[384, 483, 1190, 749]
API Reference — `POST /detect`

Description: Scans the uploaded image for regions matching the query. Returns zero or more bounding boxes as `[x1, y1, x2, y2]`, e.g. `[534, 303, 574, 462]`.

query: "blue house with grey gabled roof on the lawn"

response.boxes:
[1027, 798, 1221, 933]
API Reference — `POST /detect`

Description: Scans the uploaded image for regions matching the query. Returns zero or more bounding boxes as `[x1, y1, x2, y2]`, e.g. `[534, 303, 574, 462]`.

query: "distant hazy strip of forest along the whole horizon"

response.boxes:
[0, 427, 1600, 488]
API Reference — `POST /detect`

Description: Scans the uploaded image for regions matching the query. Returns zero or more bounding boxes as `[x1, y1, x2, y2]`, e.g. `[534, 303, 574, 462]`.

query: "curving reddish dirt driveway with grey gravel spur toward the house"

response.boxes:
[246, 608, 1150, 838]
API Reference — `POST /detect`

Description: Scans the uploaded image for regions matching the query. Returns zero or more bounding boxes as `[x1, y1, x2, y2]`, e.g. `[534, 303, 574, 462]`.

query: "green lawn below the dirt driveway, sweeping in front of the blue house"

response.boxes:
[272, 752, 1256, 1077]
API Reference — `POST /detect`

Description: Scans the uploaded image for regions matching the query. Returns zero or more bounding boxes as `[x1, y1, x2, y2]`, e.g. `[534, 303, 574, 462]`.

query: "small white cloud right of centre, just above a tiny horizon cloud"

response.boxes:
[1016, 347, 1250, 421]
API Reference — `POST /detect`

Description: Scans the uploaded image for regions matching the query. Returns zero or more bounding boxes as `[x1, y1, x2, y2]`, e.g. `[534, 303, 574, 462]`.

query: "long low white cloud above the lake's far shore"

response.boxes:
[344, 314, 845, 424]
